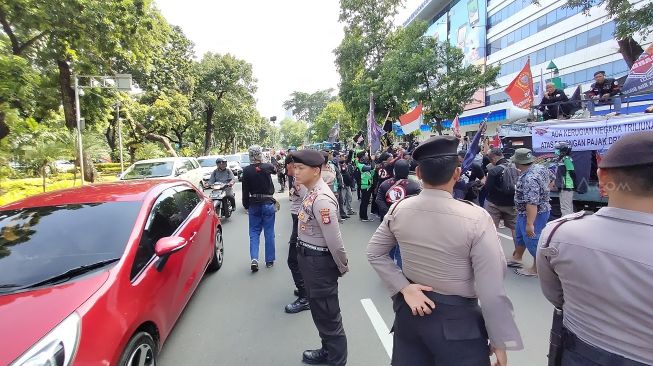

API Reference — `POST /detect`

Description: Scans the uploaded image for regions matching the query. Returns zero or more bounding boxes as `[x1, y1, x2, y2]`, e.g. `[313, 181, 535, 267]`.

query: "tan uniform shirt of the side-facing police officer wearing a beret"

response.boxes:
[297, 179, 349, 274]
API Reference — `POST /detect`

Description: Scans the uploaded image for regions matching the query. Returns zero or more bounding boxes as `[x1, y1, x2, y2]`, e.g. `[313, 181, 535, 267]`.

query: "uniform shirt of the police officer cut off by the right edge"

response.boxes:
[536, 207, 653, 365]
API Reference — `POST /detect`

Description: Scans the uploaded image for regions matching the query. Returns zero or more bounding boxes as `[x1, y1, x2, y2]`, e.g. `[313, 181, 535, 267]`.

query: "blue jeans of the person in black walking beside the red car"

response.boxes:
[248, 203, 276, 262]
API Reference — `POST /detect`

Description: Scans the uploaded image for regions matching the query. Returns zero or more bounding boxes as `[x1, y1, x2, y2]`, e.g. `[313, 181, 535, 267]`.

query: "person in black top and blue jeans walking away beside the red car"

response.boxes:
[242, 145, 276, 272]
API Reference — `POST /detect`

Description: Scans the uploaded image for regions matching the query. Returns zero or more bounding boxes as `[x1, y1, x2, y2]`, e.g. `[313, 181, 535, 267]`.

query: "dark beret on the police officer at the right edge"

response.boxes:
[599, 131, 653, 169]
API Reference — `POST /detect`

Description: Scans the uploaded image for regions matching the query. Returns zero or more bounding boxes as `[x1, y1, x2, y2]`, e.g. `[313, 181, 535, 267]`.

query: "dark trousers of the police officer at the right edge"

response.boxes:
[560, 329, 647, 366]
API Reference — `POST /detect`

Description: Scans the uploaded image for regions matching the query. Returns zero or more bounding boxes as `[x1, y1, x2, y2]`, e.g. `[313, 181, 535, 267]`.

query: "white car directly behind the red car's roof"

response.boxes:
[120, 157, 202, 190]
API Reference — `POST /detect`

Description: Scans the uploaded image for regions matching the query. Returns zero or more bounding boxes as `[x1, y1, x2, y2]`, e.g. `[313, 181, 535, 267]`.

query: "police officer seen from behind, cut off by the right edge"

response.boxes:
[537, 131, 653, 366]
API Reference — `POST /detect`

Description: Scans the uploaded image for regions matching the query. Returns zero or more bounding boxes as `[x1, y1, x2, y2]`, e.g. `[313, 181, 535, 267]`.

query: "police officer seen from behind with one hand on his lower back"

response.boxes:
[367, 136, 523, 366]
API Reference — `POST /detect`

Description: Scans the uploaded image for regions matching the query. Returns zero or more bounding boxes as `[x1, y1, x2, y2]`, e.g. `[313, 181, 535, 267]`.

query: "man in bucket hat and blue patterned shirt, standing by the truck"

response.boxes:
[513, 148, 551, 277]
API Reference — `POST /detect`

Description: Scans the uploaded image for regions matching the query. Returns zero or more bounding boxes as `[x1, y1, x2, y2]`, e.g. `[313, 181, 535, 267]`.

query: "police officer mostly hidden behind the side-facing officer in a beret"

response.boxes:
[285, 153, 310, 314]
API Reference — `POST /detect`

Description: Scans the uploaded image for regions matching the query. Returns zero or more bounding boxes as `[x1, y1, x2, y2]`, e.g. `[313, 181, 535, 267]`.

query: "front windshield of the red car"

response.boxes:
[0, 202, 141, 293]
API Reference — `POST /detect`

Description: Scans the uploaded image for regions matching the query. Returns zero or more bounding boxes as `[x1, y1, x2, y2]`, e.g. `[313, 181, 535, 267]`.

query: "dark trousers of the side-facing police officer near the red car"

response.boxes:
[297, 246, 347, 366]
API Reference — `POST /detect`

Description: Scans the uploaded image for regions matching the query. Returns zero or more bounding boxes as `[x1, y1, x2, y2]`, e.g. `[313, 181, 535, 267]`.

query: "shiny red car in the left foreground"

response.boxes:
[0, 180, 224, 366]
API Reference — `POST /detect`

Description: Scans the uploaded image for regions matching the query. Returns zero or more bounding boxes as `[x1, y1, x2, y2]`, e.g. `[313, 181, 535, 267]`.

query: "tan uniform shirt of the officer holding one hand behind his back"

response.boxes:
[367, 189, 523, 350]
